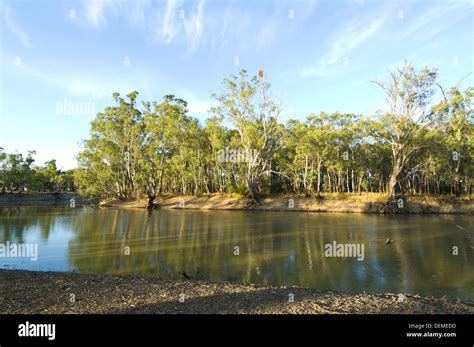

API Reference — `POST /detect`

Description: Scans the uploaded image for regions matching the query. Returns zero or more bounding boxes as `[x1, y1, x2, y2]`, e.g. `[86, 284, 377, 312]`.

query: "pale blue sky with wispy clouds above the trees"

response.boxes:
[0, 0, 474, 169]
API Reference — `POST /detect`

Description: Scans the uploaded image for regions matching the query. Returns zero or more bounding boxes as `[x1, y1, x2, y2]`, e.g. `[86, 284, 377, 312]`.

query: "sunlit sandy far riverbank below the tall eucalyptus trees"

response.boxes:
[100, 193, 474, 214]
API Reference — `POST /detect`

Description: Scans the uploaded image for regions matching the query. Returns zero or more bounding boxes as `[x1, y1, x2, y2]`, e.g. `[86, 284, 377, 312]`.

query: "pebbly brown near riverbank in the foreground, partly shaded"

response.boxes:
[0, 270, 474, 314]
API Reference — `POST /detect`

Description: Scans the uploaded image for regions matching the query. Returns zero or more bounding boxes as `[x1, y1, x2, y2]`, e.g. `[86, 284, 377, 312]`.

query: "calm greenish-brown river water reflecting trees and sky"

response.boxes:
[0, 207, 474, 299]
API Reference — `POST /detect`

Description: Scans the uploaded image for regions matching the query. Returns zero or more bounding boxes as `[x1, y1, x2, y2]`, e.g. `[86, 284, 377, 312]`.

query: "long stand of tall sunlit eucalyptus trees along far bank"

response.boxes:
[75, 63, 474, 206]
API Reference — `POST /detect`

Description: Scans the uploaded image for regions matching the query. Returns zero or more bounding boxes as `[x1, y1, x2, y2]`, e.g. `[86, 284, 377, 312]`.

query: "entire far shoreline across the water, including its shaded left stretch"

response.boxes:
[0, 193, 474, 215]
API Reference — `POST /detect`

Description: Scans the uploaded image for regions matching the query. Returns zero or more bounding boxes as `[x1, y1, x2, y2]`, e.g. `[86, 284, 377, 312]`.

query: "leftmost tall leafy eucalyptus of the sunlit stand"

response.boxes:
[75, 92, 143, 199]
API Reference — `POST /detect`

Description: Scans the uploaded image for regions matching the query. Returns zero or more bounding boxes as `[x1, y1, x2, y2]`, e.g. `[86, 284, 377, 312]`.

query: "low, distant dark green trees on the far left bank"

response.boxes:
[0, 147, 74, 194]
